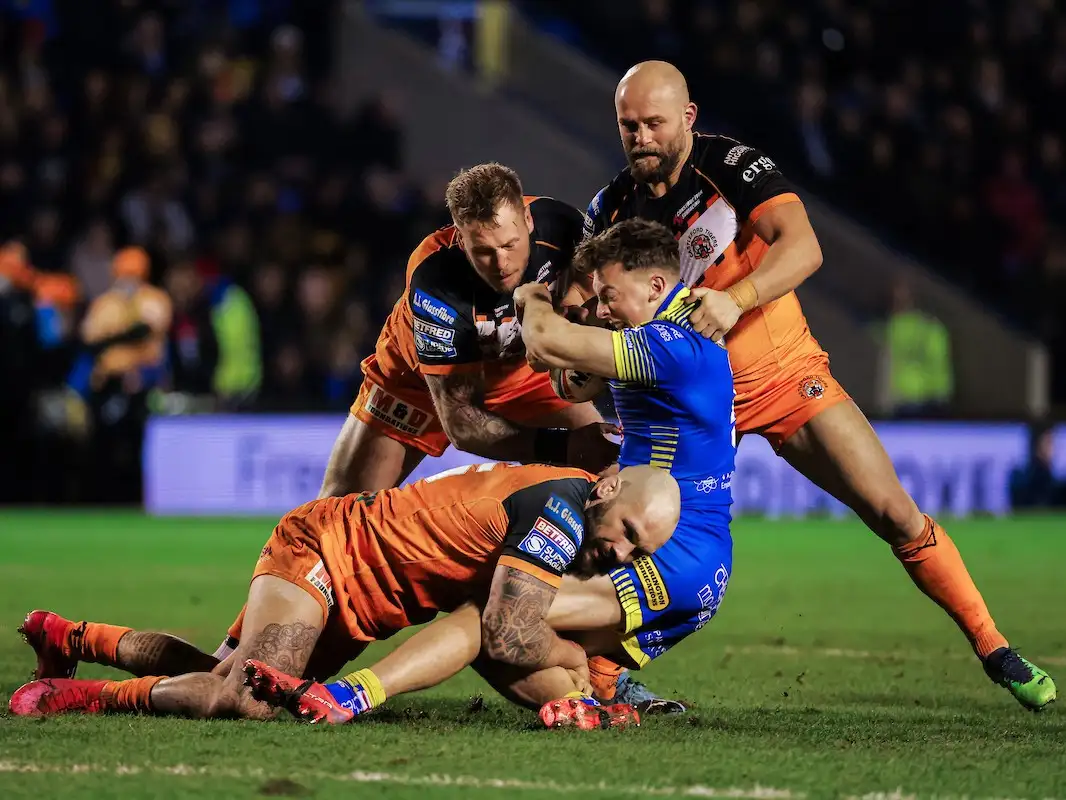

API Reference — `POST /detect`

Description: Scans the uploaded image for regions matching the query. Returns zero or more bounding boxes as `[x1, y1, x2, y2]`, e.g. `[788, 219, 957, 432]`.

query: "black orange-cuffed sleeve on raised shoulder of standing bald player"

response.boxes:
[700, 138, 800, 222]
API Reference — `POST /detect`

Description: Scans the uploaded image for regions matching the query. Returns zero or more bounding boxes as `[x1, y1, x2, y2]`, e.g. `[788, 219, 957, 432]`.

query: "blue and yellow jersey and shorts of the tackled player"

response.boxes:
[610, 284, 737, 667]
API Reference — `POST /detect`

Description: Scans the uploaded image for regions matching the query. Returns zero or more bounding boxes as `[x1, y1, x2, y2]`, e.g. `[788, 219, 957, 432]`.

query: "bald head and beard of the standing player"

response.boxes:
[614, 61, 696, 185]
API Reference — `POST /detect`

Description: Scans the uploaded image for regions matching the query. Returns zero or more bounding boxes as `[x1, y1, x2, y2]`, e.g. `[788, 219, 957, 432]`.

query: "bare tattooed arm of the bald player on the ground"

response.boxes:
[481, 564, 586, 670]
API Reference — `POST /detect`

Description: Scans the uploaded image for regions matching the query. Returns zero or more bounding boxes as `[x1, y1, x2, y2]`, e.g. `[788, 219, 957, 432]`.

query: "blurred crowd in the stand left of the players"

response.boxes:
[0, 0, 454, 496]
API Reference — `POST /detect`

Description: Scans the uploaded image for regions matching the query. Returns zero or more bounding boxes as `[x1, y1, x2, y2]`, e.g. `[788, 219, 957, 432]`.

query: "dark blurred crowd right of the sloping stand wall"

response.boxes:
[526, 0, 1066, 401]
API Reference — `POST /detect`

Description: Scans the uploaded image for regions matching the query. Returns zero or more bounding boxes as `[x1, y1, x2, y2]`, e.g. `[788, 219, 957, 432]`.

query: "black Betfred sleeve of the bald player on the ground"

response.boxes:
[499, 478, 593, 588]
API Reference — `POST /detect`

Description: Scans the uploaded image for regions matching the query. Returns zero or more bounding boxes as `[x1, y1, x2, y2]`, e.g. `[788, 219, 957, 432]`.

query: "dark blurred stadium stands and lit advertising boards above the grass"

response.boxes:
[0, 0, 1066, 513]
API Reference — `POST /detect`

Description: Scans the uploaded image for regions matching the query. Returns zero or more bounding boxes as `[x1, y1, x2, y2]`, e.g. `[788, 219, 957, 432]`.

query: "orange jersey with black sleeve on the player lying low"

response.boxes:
[336, 464, 596, 635]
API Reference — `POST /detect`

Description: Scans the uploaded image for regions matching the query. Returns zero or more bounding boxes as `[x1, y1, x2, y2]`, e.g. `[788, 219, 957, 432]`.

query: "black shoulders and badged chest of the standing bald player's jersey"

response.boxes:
[584, 133, 798, 286]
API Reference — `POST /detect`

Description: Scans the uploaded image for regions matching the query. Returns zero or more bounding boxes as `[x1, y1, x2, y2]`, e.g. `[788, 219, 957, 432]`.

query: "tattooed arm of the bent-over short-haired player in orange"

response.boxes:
[425, 372, 534, 463]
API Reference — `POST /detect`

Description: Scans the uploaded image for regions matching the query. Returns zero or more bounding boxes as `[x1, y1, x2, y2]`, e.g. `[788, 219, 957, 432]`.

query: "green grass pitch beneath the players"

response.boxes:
[0, 512, 1066, 799]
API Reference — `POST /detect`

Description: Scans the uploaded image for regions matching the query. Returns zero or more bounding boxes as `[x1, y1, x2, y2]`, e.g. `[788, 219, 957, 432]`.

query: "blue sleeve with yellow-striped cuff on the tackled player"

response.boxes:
[612, 321, 702, 388]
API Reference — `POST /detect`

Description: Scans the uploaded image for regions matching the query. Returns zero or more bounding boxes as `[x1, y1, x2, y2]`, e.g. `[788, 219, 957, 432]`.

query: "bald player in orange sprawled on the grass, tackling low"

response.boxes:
[10, 464, 681, 719]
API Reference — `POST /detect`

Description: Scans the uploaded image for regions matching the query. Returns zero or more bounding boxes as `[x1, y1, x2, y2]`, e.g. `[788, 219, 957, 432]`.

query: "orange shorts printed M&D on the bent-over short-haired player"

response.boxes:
[352, 355, 570, 457]
